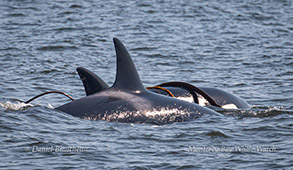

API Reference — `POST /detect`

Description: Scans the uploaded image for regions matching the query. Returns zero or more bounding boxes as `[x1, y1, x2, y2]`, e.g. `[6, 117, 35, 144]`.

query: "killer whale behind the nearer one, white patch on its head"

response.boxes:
[76, 67, 250, 109]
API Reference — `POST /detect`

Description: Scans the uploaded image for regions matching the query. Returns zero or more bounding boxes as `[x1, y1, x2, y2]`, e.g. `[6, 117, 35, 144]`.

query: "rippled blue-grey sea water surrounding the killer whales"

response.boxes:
[0, 0, 293, 169]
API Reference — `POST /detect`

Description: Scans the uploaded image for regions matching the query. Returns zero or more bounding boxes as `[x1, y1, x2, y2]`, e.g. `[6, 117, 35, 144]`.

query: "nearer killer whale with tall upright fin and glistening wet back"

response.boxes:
[56, 38, 221, 123]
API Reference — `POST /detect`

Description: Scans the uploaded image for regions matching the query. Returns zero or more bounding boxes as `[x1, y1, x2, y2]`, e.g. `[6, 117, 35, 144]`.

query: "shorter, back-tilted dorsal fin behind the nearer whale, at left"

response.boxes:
[76, 67, 109, 96]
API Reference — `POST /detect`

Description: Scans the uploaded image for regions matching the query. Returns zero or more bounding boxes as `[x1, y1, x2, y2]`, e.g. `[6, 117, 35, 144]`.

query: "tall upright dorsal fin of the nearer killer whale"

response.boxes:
[112, 38, 145, 91]
